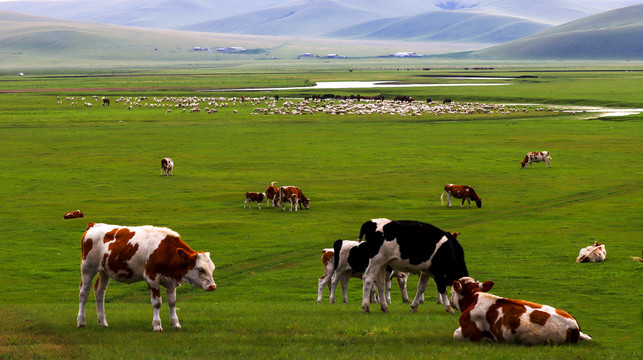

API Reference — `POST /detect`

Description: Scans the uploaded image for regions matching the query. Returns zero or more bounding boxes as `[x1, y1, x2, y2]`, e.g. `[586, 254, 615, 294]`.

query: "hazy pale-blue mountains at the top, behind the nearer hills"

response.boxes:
[0, 0, 641, 43]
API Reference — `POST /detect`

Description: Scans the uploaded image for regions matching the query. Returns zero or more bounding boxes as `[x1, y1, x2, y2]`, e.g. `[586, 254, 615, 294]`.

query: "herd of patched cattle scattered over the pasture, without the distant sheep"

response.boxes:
[64, 140, 620, 344]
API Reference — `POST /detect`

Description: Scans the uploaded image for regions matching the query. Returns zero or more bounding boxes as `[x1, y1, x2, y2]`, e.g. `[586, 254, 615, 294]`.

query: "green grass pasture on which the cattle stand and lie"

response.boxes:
[0, 70, 643, 359]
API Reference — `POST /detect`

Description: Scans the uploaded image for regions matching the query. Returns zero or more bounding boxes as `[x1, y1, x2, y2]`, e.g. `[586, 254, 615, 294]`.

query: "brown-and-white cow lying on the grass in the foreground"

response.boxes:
[449, 277, 592, 345]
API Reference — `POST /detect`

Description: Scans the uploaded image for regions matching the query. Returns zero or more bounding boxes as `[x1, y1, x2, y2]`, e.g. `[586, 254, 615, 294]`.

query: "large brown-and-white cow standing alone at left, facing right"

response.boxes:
[77, 222, 217, 331]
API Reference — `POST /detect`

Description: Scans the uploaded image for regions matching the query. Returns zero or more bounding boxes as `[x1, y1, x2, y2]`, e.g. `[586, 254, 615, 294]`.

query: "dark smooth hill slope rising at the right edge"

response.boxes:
[469, 5, 643, 60]
